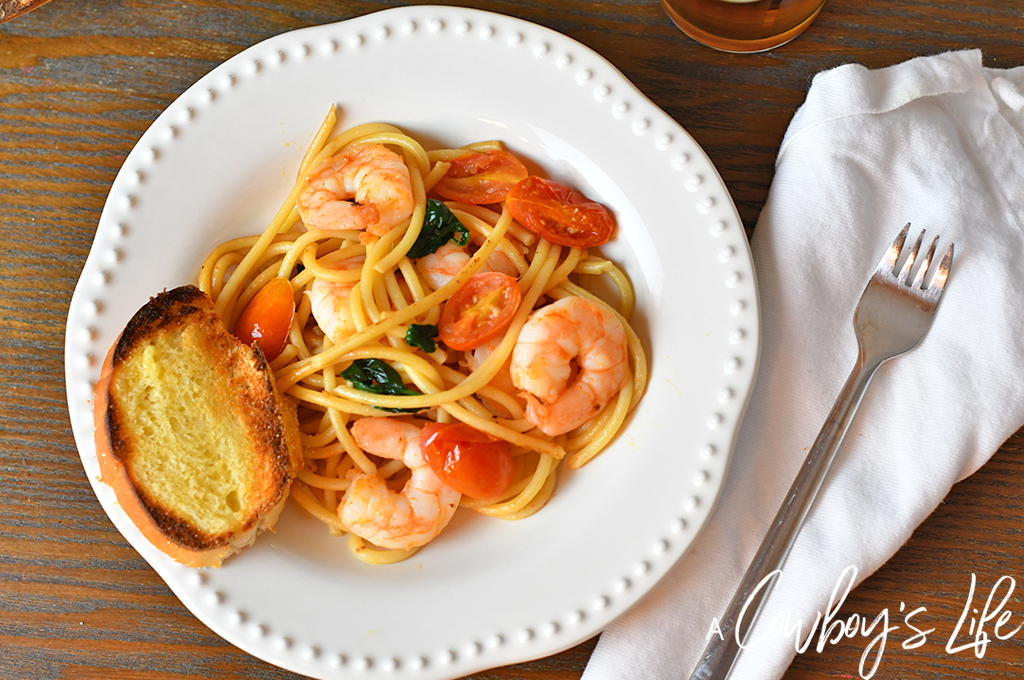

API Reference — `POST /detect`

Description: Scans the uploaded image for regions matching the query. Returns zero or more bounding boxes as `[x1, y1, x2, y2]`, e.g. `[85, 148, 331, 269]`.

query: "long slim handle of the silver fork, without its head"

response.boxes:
[690, 356, 882, 680]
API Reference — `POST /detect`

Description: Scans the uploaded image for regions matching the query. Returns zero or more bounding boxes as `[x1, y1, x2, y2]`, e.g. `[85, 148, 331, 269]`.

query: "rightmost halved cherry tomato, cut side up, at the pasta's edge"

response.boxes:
[505, 175, 615, 248]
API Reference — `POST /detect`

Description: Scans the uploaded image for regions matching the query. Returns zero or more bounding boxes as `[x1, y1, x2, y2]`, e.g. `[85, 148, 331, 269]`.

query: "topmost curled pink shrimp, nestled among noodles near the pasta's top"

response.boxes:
[297, 144, 414, 240]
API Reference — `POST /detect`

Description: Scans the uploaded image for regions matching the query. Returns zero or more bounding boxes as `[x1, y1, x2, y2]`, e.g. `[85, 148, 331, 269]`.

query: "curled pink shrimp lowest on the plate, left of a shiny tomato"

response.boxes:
[338, 418, 462, 550]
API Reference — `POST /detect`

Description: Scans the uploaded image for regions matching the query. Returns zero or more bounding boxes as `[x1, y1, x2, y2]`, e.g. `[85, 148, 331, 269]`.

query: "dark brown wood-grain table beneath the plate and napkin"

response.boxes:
[0, 0, 1024, 680]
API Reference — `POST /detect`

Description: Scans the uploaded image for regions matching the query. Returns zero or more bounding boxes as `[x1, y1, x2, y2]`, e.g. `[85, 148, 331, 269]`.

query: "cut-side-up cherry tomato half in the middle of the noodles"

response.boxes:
[437, 271, 522, 350]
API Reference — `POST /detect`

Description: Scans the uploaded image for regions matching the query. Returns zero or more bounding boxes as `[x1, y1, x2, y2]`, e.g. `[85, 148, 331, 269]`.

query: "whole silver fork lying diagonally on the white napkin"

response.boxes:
[690, 224, 953, 680]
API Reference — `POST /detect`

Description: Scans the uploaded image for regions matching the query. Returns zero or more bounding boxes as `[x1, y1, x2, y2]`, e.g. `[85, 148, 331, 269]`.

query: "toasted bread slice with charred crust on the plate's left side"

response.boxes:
[93, 286, 302, 566]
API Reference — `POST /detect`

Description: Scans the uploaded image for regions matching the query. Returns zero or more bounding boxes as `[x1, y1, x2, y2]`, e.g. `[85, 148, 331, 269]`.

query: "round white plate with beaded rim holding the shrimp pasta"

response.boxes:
[66, 6, 759, 680]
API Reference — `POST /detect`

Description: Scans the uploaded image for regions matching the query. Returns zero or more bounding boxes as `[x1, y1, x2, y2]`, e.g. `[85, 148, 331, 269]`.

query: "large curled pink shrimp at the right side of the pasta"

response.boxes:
[511, 297, 628, 436]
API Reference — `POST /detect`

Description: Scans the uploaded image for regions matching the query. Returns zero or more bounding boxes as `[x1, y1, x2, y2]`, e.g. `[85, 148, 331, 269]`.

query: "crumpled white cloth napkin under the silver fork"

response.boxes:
[584, 50, 1024, 680]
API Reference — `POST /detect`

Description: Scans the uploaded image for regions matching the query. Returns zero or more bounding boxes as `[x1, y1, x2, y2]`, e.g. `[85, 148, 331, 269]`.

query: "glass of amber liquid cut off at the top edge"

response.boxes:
[662, 0, 825, 52]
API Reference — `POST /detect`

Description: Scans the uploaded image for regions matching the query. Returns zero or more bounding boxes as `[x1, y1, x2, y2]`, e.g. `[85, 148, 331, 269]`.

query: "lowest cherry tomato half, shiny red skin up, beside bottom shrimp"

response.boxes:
[420, 423, 515, 501]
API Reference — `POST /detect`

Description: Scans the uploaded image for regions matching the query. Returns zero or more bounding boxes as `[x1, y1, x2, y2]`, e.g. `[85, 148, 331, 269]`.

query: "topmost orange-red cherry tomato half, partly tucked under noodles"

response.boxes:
[434, 150, 529, 205]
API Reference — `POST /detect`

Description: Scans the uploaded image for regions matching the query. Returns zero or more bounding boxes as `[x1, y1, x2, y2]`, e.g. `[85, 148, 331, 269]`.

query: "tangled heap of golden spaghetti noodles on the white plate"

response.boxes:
[199, 108, 647, 564]
